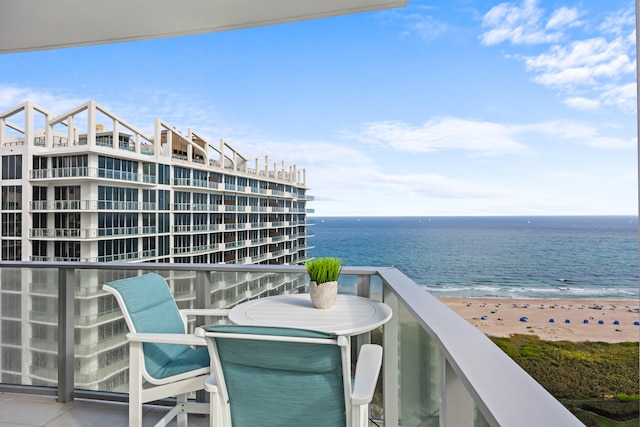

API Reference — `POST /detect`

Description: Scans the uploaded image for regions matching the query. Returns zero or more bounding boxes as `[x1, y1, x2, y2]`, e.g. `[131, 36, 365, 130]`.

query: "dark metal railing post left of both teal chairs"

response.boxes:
[58, 268, 75, 403]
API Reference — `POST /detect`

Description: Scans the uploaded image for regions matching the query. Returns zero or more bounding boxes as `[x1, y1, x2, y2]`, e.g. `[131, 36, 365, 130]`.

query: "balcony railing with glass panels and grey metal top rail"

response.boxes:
[0, 262, 581, 427]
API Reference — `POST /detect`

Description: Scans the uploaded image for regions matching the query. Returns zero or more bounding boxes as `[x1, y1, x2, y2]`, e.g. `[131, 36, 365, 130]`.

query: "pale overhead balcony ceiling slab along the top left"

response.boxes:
[0, 0, 407, 53]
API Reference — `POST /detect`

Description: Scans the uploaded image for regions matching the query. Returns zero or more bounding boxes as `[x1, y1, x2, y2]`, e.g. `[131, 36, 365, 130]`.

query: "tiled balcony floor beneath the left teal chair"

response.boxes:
[0, 393, 209, 427]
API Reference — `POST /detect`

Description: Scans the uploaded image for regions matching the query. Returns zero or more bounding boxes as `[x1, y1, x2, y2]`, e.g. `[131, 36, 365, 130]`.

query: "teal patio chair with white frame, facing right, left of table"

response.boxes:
[102, 273, 228, 427]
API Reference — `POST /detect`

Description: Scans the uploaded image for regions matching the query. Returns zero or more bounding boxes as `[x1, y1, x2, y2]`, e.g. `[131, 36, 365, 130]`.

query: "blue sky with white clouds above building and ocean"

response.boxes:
[0, 0, 638, 216]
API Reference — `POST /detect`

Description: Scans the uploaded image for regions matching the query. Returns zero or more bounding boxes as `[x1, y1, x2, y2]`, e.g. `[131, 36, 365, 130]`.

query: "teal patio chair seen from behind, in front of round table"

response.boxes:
[195, 325, 382, 427]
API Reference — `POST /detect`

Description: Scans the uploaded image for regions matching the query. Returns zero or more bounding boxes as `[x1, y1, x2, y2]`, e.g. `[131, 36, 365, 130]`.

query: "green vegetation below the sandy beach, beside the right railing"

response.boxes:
[491, 335, 640, 426]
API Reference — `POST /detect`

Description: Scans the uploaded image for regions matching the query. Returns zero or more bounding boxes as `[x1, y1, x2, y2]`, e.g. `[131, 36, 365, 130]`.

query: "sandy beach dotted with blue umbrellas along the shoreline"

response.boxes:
[440, 298, 640, 342]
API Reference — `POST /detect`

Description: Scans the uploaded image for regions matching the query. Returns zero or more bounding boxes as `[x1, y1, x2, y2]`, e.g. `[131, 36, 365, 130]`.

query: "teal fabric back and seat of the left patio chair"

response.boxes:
[103, 273, 196, 379]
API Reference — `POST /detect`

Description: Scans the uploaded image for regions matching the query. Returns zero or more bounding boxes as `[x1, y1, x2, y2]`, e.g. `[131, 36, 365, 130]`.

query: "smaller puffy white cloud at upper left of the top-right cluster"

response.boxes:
[480, 0, 579, 46]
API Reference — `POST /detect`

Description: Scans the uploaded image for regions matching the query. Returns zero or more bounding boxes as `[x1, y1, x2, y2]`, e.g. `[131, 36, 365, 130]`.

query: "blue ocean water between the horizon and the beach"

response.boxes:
[311, 216, 639, 299]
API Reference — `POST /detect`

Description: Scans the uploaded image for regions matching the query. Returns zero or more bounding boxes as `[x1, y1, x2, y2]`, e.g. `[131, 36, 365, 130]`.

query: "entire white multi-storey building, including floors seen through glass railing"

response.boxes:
[0, 101, 312, 391]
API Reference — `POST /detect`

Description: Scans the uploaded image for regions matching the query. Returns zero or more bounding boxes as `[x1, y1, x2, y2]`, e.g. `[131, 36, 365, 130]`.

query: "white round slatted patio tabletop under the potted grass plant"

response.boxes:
[229, 294, 392, 336]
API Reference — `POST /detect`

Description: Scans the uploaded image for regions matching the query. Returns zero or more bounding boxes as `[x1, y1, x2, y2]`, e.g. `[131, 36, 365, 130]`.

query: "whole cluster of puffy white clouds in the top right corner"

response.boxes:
[481, 0, 636, 113]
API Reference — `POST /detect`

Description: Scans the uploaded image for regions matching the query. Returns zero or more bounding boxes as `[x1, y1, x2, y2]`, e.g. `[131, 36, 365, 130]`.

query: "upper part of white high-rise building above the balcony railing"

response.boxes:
[0, 101, 311, 264]
